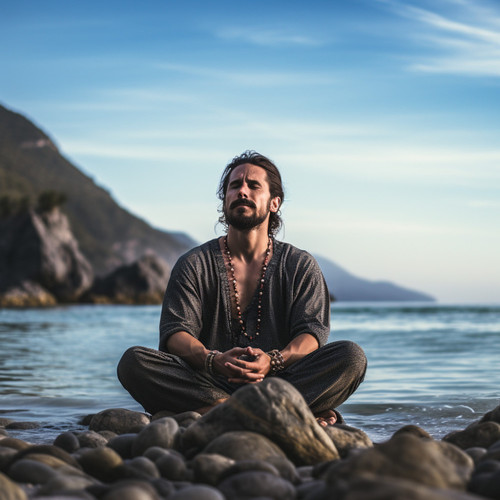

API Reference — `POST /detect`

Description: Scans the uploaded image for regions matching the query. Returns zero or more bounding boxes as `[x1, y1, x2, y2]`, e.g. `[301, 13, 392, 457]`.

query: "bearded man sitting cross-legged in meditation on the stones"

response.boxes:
[118, 151, 366, 426]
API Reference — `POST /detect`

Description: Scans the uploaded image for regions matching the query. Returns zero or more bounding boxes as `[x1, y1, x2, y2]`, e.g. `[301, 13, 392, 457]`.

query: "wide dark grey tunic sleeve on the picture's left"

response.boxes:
[159, 257, 202, 351]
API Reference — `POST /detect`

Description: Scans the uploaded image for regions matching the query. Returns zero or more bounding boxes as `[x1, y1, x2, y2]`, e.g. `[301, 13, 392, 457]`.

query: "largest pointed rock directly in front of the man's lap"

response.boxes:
[181, 377, 339, 465]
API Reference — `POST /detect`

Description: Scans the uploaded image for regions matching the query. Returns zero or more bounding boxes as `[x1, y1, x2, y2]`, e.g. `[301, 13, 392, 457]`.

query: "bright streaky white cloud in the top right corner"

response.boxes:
[384, 0, 500, 77]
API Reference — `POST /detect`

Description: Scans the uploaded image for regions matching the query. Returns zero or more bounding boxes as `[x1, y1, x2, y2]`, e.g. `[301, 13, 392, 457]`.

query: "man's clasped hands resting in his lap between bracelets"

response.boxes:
[214, 347, 271, 384]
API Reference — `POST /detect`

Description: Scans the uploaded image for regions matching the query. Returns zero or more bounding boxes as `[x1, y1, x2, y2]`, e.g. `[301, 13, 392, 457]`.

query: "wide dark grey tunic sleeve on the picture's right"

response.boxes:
[287, 252, 330, 346]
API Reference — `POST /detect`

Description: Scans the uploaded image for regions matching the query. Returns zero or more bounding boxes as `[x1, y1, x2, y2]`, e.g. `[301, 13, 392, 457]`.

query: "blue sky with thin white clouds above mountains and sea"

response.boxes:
[0, 0, 500, 303]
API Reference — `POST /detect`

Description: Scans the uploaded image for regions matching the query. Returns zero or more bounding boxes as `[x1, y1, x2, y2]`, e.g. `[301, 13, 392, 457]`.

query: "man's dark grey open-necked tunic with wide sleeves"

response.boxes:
[159, 239, 330, 352]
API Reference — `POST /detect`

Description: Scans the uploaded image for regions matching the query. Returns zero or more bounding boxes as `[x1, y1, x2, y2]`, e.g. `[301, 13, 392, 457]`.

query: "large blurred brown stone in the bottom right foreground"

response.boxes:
[326, 434, 474, 490]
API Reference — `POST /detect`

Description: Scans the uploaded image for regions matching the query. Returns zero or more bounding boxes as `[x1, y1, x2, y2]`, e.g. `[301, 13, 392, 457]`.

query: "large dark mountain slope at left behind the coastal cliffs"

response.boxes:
[0, 105, 196, 275]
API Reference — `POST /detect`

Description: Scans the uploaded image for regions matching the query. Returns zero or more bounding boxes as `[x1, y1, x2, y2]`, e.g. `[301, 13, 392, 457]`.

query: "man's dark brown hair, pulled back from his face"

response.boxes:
[217, 150, 285, 236]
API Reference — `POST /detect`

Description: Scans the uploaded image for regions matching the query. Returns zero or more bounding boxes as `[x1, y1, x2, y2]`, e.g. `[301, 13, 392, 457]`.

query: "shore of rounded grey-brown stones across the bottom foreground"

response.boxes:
[0, 378, 500, 500]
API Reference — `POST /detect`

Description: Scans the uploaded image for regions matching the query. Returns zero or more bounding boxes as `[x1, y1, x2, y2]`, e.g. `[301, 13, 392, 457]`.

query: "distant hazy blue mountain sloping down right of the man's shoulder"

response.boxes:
[315, 255, 435, 302]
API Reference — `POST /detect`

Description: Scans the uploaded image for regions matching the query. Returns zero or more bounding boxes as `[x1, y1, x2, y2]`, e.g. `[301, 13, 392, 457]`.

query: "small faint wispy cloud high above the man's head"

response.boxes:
[216, 27, 324, 47]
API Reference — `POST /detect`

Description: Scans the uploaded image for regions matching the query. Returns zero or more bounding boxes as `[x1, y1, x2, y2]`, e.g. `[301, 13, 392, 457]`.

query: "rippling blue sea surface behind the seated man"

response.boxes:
[0, 303, 500, 443]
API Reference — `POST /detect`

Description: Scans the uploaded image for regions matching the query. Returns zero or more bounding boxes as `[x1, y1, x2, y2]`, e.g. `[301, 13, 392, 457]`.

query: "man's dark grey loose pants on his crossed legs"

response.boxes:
[118, 341, 366, 414]
